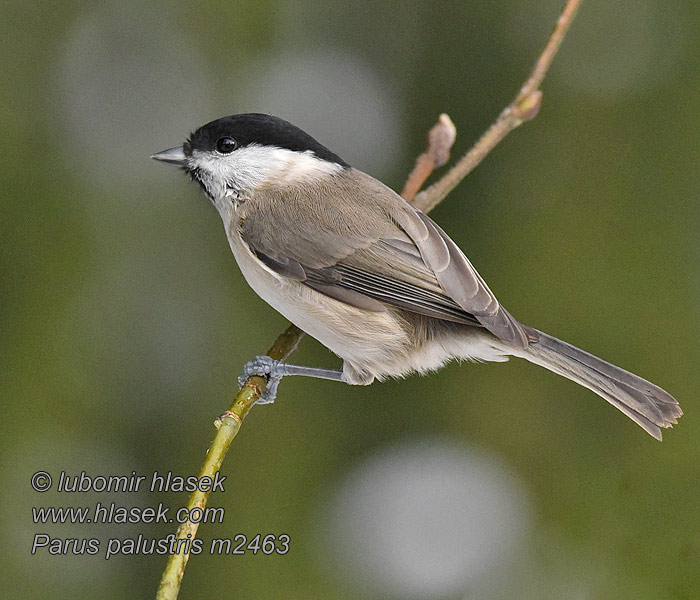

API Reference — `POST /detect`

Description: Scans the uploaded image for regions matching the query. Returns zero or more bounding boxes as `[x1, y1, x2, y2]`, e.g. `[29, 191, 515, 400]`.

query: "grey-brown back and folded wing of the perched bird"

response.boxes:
[240, 169, 527, 347]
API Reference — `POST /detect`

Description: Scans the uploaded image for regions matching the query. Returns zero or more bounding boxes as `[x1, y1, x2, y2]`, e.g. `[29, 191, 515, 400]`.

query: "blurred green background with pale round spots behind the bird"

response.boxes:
[0, 0, 700, 600]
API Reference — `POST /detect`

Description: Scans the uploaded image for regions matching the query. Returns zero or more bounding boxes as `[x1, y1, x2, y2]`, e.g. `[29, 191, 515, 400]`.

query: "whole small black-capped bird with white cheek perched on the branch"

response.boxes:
[152, 113, 682, 439]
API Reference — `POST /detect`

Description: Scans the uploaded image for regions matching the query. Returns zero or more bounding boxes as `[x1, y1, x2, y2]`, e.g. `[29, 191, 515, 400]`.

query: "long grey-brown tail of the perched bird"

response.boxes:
[517, 327, 683, 440]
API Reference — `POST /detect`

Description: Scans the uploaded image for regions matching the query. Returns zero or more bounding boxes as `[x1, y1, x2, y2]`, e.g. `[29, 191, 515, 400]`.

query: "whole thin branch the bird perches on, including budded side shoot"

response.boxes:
[156, 0, 581, 600]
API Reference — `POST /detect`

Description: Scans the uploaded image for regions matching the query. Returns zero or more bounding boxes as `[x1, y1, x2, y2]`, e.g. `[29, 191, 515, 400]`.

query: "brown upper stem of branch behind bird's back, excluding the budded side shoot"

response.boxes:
[413, 0, 581, 212]
